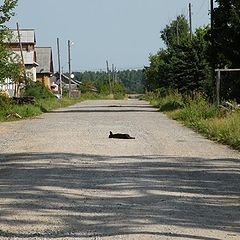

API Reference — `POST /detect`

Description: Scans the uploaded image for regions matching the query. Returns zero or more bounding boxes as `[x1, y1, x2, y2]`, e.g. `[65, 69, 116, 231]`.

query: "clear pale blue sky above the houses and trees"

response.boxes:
[7, 0, 210, 72]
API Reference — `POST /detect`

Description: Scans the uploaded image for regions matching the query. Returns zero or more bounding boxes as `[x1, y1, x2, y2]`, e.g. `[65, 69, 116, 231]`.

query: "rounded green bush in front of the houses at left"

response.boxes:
[22, 81, 54, 99]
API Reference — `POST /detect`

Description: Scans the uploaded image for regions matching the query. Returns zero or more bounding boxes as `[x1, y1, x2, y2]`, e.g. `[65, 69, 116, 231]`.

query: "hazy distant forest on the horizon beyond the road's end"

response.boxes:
[74, 70, 145, 93]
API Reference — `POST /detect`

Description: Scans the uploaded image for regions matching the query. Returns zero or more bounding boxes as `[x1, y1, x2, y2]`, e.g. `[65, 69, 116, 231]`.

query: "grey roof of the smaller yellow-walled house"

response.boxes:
[35, 47, 53, 73]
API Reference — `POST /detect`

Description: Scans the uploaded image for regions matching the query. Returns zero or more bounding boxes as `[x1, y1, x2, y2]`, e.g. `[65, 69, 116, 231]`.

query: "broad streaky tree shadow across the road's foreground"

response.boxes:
[0, 153, 240, 240]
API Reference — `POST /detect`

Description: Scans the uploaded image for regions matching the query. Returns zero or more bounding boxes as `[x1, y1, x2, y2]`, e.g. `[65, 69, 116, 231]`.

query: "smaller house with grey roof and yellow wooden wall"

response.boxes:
[35, 47, 54, 89]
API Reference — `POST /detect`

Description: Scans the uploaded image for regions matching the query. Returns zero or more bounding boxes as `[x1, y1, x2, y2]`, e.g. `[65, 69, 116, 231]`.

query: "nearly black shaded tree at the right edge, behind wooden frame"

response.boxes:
[210, 0, 240, 101]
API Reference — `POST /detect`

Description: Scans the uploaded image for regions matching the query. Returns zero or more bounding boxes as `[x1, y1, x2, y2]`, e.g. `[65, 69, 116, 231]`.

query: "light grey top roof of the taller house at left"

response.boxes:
[11, 29, 36, 44]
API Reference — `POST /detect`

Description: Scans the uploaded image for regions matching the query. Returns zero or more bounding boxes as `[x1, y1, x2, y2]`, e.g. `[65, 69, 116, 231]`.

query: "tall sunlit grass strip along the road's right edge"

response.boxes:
[145, 92, 240, 150]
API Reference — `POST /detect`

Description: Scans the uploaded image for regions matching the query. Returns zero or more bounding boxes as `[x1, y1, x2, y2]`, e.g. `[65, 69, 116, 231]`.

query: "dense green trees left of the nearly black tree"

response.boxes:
[144, 21, 211, 93]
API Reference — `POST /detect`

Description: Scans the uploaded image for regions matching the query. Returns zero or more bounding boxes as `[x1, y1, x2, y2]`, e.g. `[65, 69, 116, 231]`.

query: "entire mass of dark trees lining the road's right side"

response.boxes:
[144, 0, 240, 100]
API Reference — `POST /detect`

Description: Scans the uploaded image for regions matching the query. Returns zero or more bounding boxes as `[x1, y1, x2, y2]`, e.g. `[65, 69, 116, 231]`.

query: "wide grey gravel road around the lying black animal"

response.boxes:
[0, 99, 240, 240]
